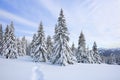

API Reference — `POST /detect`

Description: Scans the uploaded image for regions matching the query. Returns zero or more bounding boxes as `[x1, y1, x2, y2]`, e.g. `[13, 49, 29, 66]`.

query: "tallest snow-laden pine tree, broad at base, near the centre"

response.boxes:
[51, 9, 76, 66]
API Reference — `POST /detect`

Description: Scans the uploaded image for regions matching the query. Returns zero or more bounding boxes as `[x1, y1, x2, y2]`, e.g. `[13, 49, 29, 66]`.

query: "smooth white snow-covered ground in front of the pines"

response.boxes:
[0, 56, 120, 80]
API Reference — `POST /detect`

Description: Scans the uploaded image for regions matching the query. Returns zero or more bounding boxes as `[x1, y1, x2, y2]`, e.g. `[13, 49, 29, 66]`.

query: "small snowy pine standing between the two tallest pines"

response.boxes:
[46, 35, 53, 59]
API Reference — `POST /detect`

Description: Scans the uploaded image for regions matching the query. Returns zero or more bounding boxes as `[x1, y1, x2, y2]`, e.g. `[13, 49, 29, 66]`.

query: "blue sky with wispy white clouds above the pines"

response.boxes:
[0, 0, 120, 48]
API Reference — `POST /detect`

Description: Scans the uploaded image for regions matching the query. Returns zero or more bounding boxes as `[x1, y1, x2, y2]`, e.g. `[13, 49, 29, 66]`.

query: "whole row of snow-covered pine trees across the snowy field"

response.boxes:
[0, 9, 102, 66]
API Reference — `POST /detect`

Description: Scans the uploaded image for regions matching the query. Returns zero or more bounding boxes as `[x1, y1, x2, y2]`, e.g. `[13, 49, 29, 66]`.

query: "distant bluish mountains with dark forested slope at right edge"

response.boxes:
[98, 48, 120, 65]
